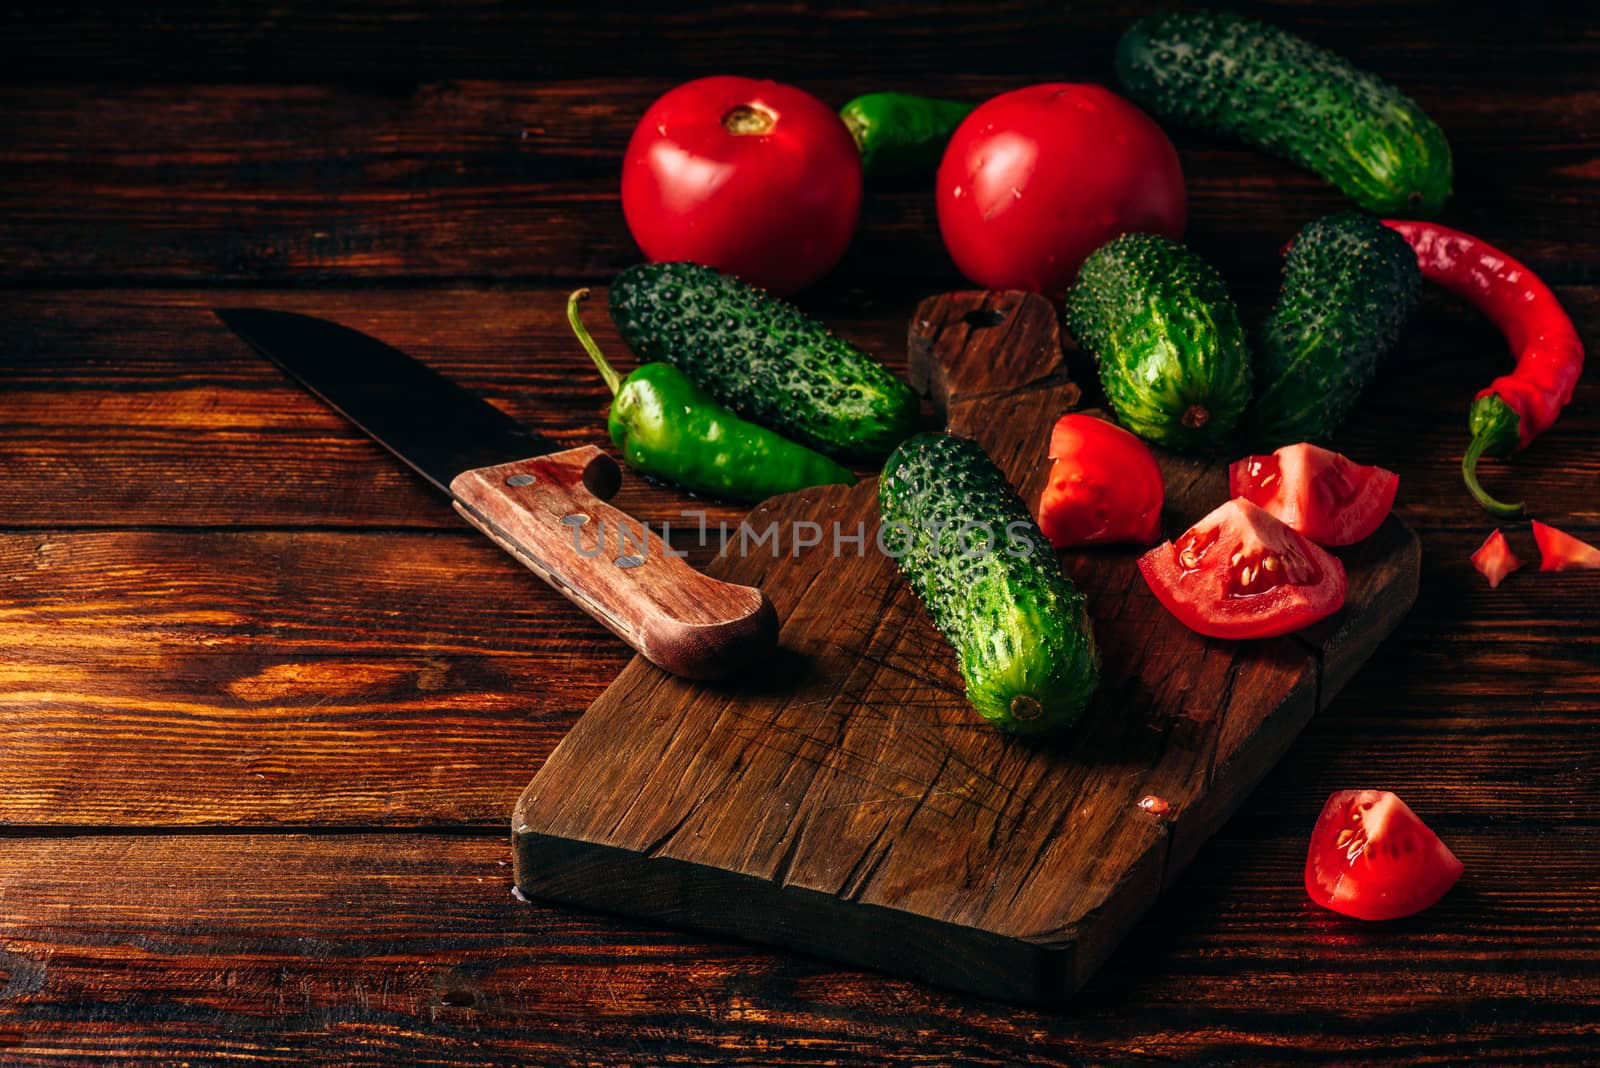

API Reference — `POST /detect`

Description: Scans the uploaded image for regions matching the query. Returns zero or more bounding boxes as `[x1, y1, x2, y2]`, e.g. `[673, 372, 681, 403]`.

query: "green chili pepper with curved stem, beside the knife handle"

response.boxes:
[566, 289, 856, 502]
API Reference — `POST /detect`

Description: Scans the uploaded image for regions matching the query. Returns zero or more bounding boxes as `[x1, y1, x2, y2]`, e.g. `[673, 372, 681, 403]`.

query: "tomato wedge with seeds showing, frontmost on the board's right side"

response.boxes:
[1139, 497, 1344, 638]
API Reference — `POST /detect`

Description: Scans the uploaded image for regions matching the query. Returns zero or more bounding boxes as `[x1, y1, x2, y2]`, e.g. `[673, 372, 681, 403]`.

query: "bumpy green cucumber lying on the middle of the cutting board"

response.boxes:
[878, 433, 1099, 734]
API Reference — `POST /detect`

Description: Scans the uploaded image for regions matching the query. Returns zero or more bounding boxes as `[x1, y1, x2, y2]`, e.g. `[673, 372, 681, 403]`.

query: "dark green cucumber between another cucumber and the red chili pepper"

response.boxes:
[1248, 211, 1422, 449]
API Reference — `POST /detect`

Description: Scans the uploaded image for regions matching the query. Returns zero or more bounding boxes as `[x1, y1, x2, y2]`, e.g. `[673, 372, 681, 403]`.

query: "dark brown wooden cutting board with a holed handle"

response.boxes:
[512, 293, 1419, 1004]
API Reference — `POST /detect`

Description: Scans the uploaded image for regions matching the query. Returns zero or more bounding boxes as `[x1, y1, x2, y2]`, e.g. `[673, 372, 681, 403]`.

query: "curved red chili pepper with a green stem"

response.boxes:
[1384, 219, 1584, 515]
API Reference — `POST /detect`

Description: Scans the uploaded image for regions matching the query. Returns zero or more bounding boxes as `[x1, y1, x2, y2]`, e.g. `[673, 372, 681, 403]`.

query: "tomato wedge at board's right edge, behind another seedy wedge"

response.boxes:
[1227, 441, 1400, 545]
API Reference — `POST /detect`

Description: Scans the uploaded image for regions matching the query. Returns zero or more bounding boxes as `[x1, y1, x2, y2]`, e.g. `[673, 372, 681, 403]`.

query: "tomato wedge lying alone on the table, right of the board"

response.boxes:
[1306, 790, 1462, 919]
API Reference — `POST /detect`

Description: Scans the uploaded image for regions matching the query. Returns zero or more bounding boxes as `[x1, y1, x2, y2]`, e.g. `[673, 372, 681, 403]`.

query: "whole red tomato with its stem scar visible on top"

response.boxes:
[622, 77, 861, 294]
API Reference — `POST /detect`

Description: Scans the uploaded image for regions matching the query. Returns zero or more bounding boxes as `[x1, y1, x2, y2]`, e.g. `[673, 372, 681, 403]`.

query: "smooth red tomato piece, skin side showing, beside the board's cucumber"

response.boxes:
[1038, 416, 1165, 548]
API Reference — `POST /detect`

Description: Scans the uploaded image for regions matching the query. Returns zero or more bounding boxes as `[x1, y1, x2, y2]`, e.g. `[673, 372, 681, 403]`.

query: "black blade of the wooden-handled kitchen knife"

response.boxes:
[214, 307, 560, 496]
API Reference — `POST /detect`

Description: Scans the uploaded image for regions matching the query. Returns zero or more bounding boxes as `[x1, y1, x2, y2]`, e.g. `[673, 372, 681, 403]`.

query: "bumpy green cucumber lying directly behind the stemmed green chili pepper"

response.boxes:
[610, 264, 918, 462]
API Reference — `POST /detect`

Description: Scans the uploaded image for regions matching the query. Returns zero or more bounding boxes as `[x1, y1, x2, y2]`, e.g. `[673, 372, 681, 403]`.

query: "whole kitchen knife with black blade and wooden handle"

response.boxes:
[216, 309, 778, 678]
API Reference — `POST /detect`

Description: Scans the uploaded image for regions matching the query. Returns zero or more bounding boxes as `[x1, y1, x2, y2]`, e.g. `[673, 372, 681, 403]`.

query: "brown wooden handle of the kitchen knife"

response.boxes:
[450, 444, 778, 678]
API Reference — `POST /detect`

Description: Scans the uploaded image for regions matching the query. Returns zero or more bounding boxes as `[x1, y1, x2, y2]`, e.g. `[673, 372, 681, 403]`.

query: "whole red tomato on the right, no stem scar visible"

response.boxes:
[936, 82, 1187, 296]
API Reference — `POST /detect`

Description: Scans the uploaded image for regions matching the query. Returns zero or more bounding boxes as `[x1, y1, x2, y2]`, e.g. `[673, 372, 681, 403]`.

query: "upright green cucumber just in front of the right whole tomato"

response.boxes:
[1066, 233, 1250, 451]
